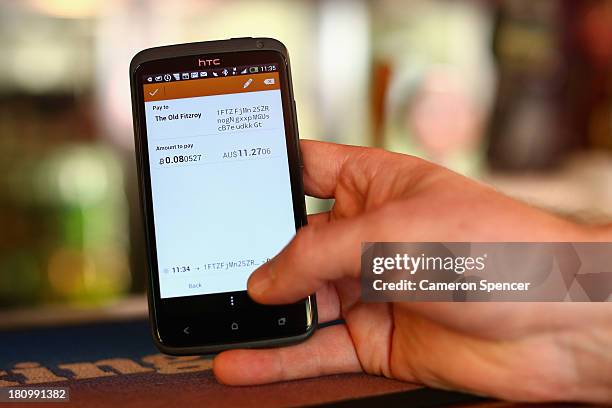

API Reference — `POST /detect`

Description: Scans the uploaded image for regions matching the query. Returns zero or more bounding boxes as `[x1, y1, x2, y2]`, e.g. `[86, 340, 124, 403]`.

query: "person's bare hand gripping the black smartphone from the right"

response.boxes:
[214, 141, 612, 401]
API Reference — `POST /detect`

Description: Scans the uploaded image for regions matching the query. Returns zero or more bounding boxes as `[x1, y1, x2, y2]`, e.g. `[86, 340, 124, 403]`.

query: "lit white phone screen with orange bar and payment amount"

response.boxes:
[143, 63, 296, 299]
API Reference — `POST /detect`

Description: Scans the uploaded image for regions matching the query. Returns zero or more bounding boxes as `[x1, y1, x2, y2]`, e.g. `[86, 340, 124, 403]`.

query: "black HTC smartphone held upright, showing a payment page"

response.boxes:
[130, 38, 317, 355]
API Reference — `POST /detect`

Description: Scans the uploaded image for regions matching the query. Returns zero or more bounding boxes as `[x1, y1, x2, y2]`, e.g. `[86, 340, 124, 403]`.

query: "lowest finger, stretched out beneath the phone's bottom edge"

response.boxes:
[213, 325, 362, 385]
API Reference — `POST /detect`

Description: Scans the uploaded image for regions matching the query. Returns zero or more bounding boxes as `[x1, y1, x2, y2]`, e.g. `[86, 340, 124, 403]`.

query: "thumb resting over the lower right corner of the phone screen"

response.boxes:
[248, 216, 367, 304]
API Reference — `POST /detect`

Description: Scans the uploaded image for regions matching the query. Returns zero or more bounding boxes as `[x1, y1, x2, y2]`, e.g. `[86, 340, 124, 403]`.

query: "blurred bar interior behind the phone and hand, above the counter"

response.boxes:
[0, 0, 612, 325]
